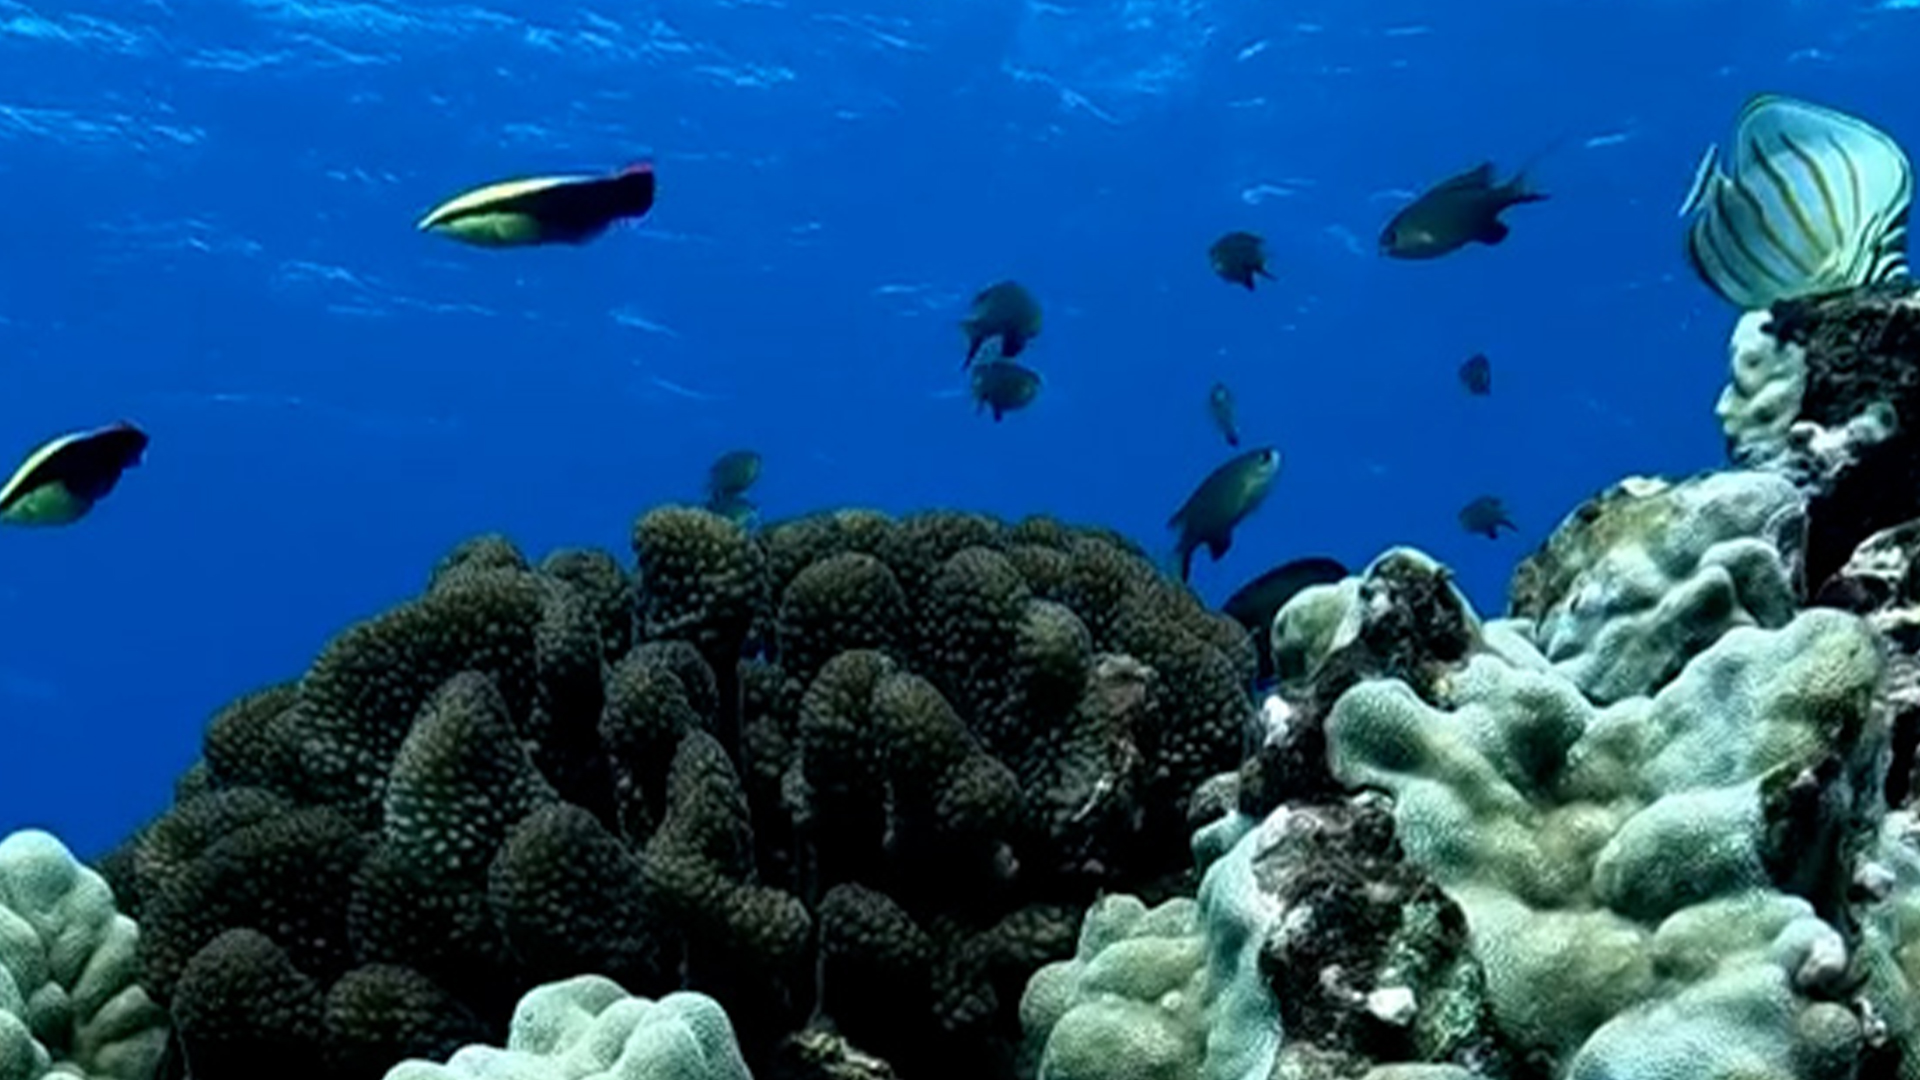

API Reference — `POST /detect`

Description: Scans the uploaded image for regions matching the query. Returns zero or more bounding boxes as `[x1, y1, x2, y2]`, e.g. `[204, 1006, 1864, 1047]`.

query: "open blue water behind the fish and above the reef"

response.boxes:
[0, 0, 1896, 853]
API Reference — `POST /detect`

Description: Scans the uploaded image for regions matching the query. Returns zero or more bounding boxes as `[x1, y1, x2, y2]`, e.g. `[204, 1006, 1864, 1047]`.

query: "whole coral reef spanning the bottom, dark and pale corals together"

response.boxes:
[11, 345, 1920, 1080]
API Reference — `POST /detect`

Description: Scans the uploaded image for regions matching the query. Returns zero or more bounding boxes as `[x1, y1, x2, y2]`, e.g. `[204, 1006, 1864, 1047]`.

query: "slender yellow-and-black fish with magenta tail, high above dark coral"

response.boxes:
[419, 161, 653, 248]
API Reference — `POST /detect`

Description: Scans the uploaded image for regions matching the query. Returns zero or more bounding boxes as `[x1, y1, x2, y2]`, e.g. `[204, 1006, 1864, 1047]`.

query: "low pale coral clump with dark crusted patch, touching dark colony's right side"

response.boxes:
[1021, 796, 1509, 1080]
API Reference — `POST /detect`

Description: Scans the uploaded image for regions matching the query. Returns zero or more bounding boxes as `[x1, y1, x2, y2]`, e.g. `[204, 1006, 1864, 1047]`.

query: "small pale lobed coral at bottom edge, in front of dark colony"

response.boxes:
[386, 974, 751, 1080]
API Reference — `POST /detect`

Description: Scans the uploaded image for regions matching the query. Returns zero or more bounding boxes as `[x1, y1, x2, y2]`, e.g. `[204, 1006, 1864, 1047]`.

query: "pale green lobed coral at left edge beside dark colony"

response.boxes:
[0, 830, 167, 1080]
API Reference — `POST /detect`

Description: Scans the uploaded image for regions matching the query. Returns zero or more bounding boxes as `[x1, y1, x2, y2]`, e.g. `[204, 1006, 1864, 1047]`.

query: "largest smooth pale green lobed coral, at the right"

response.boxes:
[1327, 609, 1887, 1080]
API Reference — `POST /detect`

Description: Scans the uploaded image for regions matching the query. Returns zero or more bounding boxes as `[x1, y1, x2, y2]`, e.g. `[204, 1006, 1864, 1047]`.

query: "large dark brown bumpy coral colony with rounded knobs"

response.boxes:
[104, 507, 1254, 1080]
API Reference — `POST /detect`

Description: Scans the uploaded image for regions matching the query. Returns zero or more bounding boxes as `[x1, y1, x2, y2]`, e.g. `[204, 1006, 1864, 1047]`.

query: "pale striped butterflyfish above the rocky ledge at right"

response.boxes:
[1680, 94, 1914, 311]
